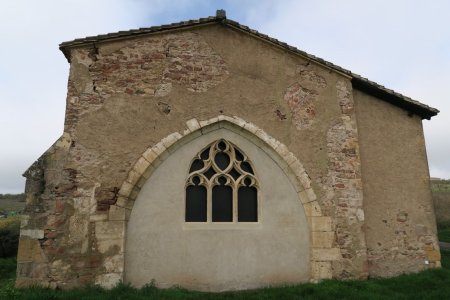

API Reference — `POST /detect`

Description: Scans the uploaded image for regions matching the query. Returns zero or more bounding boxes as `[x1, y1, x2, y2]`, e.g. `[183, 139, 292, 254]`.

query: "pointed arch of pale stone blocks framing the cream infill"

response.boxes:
[103, 115, 340, 285]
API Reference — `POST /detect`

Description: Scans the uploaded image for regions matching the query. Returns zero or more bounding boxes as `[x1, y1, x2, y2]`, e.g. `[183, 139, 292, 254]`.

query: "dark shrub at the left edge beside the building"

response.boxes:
[0, 216, 20, 257]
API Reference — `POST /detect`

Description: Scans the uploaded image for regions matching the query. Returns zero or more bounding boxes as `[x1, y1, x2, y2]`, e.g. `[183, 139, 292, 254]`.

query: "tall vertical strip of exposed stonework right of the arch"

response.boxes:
[319, 80, 368, 278]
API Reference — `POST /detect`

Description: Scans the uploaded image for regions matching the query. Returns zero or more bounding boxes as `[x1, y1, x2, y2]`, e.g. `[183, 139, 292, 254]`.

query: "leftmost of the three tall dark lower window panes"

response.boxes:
[185, 180, 206, 222]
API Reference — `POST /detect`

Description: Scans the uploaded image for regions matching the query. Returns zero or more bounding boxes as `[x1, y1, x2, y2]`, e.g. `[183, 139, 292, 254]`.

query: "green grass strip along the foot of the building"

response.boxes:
[0, 252, 450, 300]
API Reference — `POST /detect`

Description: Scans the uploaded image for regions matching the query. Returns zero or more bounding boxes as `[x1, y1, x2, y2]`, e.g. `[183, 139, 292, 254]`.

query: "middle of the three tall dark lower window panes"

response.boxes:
[212, 179, 233, 222]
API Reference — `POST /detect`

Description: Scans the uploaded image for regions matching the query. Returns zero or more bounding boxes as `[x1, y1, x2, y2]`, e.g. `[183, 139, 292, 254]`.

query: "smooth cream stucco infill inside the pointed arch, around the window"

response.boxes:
[125, 128, 310, 291]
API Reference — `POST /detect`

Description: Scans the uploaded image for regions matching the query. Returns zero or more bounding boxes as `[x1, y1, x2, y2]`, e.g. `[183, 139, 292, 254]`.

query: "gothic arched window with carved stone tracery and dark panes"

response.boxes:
[185, 139, 258, 222]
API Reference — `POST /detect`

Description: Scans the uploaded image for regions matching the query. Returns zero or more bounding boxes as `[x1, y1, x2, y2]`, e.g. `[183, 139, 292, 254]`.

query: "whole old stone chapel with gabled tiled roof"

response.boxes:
[16, 10, 440, 291]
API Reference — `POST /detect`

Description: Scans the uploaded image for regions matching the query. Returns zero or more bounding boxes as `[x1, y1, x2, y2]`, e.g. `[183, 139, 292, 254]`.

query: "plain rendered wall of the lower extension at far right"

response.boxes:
[353, 90, 440, 276]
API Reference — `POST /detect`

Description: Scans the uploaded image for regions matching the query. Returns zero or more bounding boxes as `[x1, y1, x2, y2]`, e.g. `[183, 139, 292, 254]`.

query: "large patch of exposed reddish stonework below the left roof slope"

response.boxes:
[89, 32, 229, 97]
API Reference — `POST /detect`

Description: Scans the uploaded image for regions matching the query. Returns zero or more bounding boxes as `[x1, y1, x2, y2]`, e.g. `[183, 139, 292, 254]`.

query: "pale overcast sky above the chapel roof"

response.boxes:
[0, 0, 450, 193]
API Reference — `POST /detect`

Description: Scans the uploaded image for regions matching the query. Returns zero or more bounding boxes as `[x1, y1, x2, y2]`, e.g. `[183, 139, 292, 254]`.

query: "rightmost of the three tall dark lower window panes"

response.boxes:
[238, 186, 258, 222]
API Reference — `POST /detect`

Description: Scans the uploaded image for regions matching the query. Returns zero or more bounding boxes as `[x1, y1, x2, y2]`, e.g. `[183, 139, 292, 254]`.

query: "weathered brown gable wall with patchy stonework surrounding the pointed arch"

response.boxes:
[17, 25, 370, 287]
